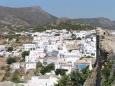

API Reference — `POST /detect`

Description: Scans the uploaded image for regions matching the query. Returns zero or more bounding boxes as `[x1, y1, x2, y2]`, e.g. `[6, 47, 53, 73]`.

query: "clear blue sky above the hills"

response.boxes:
[0, 0, 115, 20]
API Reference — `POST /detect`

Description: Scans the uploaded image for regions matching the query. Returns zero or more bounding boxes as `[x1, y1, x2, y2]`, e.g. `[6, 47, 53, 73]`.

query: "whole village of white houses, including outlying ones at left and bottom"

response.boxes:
[0, 29, 96, 86]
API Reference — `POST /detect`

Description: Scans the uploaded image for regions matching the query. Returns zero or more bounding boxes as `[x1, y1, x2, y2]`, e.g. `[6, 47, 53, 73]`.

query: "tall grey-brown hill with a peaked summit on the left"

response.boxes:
[0, 6, 57, 30]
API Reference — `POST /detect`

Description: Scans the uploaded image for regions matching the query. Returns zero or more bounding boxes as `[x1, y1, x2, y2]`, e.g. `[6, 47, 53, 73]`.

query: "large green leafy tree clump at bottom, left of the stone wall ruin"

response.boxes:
[55, 68, 90, 86]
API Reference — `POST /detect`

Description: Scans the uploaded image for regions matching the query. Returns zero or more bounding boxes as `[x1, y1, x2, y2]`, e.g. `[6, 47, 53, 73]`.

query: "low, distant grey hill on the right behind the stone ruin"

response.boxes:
[71, 17, 115, 29]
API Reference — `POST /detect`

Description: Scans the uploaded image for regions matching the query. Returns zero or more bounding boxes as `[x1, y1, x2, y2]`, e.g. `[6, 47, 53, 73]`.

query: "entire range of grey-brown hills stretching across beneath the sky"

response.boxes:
[0, 6, 115, 31]
